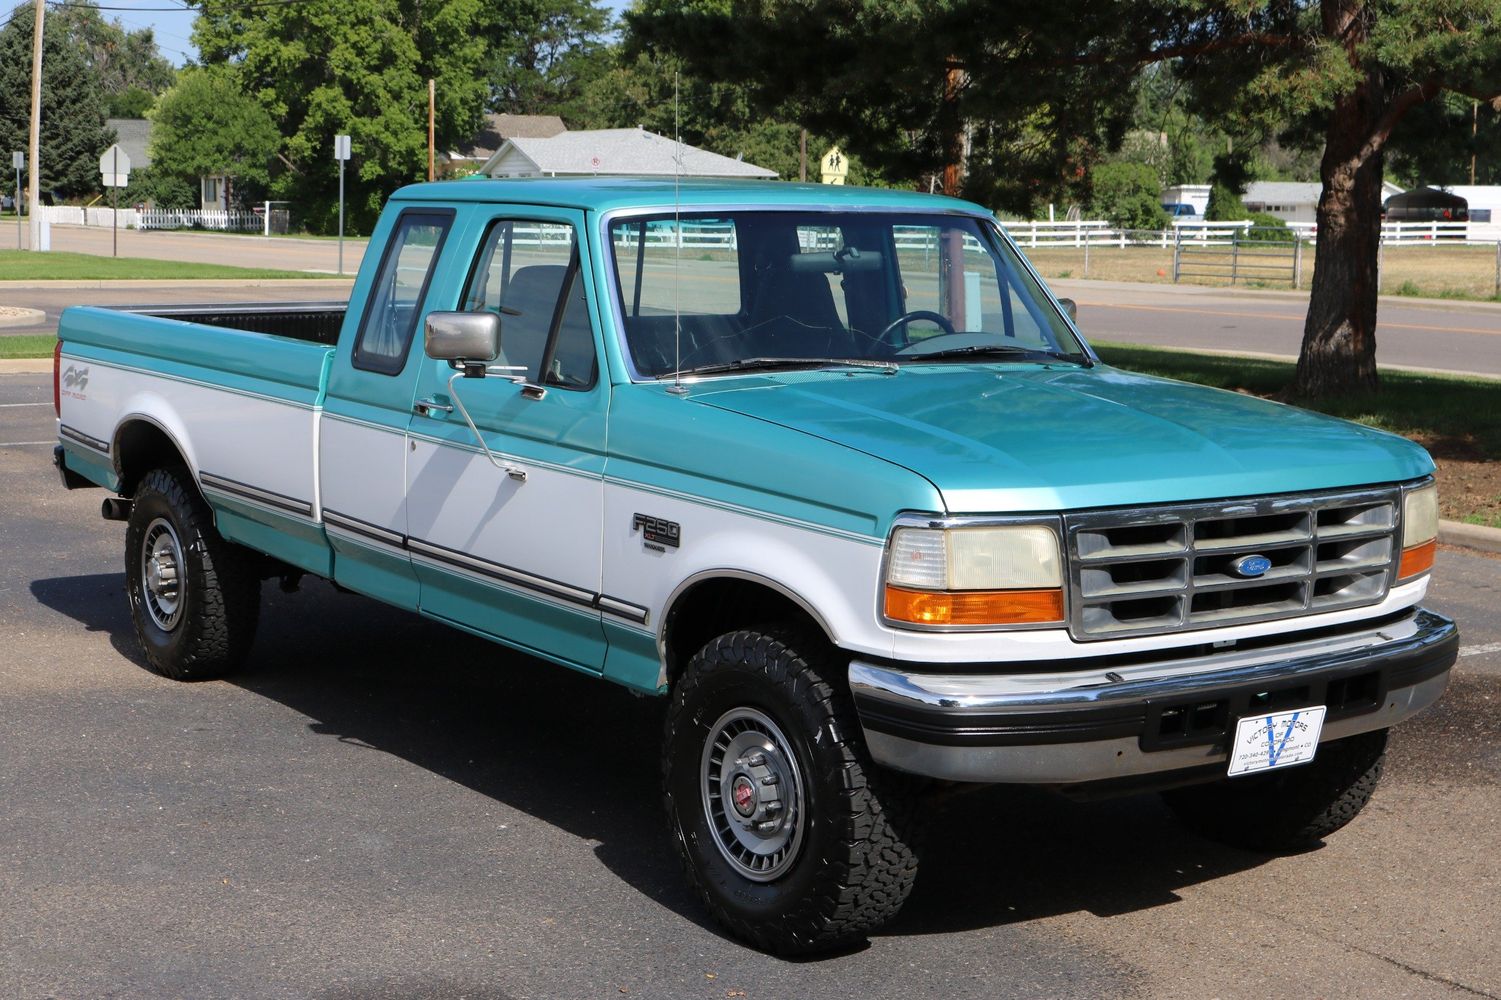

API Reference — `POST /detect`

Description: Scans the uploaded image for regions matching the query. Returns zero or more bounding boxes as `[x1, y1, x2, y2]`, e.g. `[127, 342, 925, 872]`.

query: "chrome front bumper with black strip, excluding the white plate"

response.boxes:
[850, 608, 1459, 785]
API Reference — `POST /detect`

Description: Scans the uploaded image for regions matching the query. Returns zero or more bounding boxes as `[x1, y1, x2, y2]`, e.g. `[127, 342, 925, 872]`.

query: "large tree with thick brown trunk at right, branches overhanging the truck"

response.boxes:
[626, 0, 1501, 396]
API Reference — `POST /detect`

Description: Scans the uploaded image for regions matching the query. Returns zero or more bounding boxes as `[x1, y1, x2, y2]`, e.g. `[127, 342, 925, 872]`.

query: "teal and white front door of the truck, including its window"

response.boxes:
[407, 209, 608, 673]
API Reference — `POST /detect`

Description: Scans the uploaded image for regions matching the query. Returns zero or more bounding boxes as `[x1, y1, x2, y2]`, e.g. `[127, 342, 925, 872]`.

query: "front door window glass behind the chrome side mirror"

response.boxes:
[464, 219, 599, 389]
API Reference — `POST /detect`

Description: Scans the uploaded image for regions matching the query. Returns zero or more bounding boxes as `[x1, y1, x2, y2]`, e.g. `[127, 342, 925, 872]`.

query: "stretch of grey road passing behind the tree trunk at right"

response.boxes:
[1049, 281, 1501, 378]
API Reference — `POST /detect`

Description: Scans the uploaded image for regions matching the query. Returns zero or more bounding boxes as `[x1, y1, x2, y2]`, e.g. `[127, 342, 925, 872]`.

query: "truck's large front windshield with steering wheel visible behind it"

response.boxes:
[609, 210, 1087, 377]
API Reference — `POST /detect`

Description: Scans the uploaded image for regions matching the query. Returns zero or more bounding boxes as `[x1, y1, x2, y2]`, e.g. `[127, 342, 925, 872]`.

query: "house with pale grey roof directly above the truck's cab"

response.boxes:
[480, 128, 776, 180]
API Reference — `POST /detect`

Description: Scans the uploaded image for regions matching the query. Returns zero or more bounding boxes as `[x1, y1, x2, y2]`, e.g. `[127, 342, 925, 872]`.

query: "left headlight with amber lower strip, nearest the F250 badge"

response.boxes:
[884, 524, 1063, 628]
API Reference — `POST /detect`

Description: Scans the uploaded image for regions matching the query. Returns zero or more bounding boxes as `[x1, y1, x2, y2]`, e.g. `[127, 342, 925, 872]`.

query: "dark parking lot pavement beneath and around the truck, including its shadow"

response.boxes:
[0, 375, 1501, 1000]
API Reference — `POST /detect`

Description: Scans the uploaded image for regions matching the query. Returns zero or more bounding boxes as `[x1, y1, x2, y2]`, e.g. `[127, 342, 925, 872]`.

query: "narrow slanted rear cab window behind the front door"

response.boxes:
[354, 212, 453, 375]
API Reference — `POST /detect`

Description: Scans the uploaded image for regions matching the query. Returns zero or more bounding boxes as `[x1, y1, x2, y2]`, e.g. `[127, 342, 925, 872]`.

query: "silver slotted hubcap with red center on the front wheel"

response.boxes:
[699, 699, 803, 881]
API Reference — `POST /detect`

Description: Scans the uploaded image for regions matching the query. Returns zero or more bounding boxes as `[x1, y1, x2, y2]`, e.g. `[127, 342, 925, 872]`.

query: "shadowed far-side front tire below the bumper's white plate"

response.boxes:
[1162, 730, 1387, 853]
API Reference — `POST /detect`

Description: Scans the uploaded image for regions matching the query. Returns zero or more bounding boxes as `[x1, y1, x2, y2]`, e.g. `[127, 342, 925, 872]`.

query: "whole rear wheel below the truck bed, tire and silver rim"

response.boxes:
[125, 468, 261, 680]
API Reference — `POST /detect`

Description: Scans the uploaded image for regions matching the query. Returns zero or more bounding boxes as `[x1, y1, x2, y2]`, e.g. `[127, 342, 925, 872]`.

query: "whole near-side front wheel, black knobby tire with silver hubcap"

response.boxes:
[662, 628, 917, 953]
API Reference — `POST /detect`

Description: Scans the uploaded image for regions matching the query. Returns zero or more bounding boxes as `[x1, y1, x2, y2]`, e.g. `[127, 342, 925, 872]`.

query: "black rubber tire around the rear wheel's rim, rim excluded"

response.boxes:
[125, 467, 260, 680]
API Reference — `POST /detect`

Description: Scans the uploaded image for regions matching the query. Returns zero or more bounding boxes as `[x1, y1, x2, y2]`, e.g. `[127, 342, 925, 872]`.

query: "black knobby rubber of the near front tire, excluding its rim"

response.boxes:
[662, 625, 920, 955]
